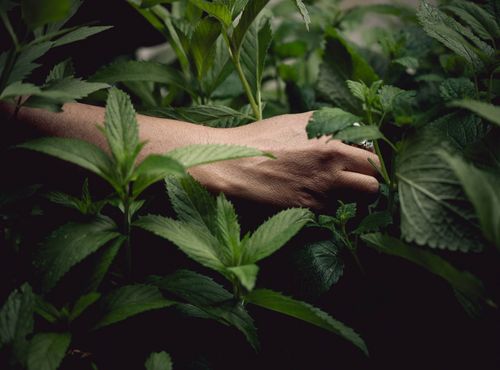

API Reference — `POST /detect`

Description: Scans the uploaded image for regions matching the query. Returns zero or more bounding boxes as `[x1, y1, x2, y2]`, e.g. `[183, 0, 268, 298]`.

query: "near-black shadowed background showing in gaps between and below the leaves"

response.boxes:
[0, 0, 500, 370]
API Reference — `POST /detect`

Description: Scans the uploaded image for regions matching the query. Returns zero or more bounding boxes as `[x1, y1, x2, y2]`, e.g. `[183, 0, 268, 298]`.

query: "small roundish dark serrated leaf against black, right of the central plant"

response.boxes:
[296, 240, 345, 294]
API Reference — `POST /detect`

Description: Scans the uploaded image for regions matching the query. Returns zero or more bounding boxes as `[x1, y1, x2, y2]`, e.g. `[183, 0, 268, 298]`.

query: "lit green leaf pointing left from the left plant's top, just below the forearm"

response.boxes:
[18, 137, 116, 186]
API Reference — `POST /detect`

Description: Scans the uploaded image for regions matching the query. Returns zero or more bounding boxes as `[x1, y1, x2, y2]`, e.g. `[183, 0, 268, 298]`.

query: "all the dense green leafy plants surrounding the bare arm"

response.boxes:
[0, 0, 500, 370]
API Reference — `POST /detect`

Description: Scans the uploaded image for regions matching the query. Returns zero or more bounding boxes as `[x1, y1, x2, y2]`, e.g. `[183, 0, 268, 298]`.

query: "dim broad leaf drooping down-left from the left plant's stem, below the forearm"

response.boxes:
[36, 216, 120, 291]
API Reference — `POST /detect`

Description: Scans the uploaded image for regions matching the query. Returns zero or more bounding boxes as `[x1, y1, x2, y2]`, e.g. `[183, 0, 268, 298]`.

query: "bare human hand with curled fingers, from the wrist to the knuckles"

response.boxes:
[190, 113, 379, 210]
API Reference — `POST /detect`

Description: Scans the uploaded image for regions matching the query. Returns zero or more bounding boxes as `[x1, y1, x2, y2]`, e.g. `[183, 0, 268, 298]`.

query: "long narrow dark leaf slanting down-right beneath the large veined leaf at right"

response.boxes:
[361, 233, 485, 301]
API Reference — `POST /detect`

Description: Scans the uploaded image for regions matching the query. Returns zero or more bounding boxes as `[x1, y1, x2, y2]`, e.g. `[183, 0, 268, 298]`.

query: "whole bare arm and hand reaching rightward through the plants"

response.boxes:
[0, 103, 379, 210]
